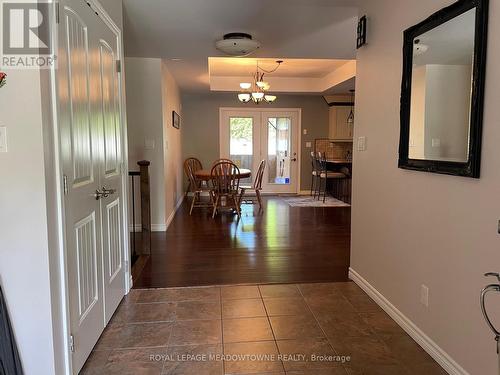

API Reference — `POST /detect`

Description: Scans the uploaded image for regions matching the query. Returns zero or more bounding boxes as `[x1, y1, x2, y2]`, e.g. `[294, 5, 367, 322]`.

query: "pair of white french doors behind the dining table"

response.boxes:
[220, 108, 300, 194]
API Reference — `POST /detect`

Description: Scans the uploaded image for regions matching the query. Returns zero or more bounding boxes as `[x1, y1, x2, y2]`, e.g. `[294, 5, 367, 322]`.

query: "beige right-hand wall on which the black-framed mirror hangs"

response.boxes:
[351, 0, 500, 375]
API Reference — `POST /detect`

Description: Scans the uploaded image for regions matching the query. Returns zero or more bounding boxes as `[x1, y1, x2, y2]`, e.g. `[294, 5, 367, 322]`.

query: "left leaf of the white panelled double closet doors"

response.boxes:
[58, 1, 104, 373]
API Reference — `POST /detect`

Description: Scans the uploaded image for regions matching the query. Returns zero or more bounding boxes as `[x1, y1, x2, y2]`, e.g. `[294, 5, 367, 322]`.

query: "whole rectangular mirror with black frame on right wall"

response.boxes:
[399, 0, 488, 178]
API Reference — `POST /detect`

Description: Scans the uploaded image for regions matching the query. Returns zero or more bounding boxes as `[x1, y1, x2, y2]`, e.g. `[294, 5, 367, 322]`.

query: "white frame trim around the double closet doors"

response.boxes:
[45, 0, 132, 374]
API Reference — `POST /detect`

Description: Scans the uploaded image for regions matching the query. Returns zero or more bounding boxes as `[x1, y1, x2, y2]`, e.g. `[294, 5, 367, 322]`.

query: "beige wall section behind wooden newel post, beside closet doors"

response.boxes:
[125, 58, 167, 230]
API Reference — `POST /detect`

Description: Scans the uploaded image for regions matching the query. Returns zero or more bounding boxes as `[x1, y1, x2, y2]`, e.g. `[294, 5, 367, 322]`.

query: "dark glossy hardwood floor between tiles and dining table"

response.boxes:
[134, 197, 351, 288]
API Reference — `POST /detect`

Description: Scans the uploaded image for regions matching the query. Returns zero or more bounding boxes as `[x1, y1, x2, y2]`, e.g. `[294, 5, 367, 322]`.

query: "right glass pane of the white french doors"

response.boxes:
[267, 117, 292, 185]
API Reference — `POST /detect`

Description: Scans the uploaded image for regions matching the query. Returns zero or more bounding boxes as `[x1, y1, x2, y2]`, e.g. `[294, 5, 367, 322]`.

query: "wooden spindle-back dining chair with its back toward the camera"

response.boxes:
[210, 161, 241, 218]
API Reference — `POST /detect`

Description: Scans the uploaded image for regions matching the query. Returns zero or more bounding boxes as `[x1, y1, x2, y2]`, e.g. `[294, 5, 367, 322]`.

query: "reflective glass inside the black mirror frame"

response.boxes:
[408, 8, 476, 163]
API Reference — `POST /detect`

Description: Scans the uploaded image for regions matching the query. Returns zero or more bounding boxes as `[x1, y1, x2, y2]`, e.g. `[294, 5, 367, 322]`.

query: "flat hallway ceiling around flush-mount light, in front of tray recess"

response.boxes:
[124, 0, 357, 92]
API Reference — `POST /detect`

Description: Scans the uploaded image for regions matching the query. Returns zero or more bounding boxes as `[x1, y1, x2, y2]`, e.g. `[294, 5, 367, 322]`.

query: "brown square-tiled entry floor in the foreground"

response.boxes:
[81, 282, 446, 375]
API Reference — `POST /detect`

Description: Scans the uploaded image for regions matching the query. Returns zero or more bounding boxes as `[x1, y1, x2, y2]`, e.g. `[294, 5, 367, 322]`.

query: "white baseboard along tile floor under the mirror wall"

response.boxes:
[349, 268, 470, 375]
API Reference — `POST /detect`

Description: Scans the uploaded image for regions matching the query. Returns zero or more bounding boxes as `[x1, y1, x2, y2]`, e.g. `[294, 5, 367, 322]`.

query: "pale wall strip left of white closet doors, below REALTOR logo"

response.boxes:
[0, 70, 57, 374]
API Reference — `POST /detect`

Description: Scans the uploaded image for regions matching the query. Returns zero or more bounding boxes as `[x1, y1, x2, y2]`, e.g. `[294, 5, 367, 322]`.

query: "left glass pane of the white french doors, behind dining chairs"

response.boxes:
[229, 117, 254, 184]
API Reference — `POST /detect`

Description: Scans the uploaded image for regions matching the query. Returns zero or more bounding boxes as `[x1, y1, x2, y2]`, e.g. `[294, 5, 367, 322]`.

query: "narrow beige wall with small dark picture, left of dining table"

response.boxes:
[161, 61, 184, 224]
